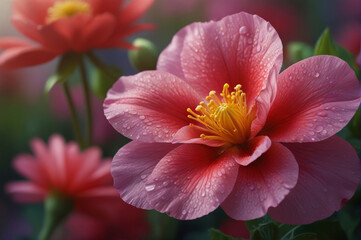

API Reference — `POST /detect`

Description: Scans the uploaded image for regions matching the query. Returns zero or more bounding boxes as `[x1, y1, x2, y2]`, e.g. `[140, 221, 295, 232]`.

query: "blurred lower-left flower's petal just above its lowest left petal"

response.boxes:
[13, 154, 48, 187]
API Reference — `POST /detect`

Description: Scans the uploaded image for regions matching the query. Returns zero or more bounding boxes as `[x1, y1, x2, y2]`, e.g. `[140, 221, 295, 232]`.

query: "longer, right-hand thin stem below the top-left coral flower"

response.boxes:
[79, 59, 93, 147]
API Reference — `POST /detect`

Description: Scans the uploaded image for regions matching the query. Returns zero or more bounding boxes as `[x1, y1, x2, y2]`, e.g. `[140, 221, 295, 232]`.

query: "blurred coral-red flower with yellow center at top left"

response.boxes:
[0, 0, 153, 69]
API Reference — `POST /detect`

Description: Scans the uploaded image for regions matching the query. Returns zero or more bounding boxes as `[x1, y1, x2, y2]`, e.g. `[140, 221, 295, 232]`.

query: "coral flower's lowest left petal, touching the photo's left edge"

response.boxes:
[0, 46, 56, 70]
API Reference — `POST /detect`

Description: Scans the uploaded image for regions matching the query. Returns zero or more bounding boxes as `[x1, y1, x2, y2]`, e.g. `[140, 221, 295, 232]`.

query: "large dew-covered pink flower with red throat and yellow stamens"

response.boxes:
[104, 13, 360, 224]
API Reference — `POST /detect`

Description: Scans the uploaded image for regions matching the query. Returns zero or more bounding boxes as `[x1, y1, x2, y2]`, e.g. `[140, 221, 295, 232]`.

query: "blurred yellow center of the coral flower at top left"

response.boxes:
[46, 0, 91, 23]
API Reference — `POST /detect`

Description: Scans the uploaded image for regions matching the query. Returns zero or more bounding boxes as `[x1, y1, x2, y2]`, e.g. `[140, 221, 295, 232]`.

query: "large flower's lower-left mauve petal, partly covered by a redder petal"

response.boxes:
[111, 141, 179, 209]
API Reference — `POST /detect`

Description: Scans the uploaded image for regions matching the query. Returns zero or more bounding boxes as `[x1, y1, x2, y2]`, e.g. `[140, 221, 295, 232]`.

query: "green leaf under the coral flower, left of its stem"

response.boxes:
[44, 52, 81, 94]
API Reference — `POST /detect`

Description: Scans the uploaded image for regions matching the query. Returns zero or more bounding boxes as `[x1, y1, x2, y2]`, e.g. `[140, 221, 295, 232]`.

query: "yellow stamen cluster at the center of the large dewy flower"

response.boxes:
[187, 83, 256, 144]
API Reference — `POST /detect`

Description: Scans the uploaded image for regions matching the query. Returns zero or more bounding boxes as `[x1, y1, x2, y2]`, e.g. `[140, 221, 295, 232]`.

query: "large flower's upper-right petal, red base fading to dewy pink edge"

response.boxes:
[261, 56, 360, 142]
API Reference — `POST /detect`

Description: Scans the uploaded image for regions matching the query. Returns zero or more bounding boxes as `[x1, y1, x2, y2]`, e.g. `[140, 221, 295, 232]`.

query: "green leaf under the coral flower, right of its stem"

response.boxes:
[90, 66, 122, 99]
